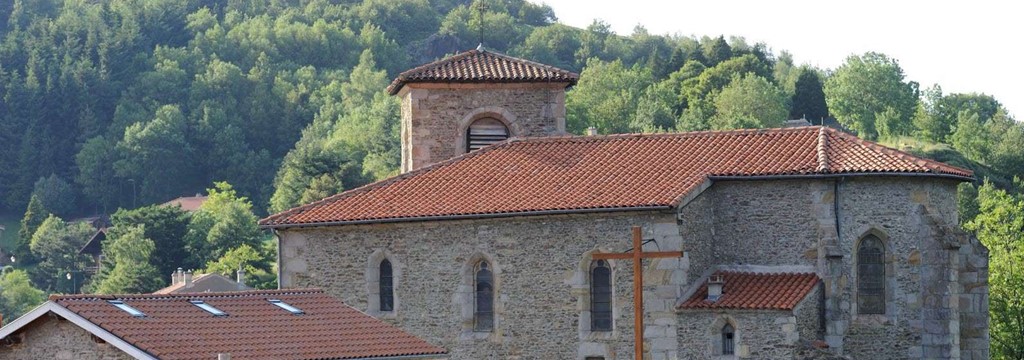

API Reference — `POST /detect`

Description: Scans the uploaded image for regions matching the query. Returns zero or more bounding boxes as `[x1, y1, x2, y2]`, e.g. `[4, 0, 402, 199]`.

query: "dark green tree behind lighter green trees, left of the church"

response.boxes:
[111, 205, 196, 275]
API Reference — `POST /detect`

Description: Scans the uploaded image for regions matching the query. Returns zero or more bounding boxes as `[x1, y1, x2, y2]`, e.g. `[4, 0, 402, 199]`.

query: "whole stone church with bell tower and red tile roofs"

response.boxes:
[260, 49, 988, 360]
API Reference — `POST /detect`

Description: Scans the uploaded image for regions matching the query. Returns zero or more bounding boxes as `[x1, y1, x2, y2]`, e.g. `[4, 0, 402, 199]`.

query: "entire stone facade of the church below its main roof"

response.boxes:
[279, 177, 988, 359]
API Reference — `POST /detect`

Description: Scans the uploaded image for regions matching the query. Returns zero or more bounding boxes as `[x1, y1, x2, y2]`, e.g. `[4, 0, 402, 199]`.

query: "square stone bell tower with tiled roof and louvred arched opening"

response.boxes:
[387, 47, 580, 173]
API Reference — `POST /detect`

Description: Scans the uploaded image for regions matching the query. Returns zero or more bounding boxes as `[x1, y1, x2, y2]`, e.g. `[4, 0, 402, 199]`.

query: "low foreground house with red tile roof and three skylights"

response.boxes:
[0, 289, 447, 360]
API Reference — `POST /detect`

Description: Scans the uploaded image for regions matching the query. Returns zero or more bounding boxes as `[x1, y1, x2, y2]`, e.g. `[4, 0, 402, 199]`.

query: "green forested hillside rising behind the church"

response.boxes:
[0, 0, 1024, 354]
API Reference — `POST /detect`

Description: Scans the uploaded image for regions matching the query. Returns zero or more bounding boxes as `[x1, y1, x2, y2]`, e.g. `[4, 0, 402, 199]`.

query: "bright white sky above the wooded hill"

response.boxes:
[543, 0, 1024, 117]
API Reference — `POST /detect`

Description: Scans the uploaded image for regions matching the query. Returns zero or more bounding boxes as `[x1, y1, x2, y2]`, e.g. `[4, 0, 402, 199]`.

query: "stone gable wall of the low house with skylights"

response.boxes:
[0, 316, 132, 360]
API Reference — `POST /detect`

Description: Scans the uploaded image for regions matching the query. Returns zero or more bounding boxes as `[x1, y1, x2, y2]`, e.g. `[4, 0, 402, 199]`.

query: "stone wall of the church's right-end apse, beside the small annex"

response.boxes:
[700, 177, 987, 358]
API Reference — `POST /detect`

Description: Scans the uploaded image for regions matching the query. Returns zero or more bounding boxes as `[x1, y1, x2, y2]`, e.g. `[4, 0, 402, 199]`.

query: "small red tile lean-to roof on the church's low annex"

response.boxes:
[679, 271, 818, 310]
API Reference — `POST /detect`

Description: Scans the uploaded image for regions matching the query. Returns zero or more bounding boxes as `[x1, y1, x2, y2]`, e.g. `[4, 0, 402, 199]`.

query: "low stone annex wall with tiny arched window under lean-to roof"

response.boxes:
[677, 310, 800, 360]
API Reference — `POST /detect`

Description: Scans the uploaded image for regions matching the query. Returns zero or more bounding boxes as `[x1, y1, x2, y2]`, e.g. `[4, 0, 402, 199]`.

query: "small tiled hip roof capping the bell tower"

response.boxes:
[387, 50, 580, 95]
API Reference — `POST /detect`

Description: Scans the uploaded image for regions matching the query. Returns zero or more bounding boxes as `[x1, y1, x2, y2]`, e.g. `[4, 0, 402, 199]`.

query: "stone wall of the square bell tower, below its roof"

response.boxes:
[398, 83, 566, 173]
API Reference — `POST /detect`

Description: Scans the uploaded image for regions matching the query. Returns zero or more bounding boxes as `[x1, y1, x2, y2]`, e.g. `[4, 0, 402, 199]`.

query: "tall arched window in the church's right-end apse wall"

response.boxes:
[857, 235, 886, 314]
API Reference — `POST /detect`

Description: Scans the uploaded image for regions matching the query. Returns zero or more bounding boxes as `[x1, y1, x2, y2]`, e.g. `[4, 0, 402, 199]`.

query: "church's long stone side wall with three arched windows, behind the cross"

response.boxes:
[280, 212, 688, 360]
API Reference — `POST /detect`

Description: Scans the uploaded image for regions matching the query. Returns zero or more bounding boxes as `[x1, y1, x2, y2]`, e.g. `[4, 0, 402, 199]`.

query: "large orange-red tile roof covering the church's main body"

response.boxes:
[260, 127, 973, 227]
